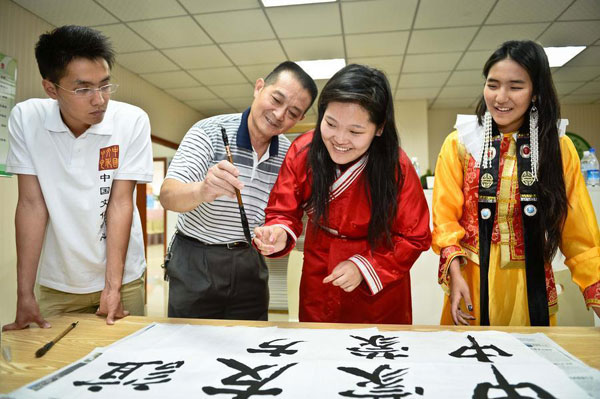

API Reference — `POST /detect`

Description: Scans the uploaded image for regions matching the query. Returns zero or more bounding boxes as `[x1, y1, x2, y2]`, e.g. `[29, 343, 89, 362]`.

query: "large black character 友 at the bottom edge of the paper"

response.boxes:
[202, 359, 298, 399]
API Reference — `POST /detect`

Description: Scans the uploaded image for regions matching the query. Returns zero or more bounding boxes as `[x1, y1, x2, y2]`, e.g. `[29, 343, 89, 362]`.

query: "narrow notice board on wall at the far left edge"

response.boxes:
[0, 53, 17, 176]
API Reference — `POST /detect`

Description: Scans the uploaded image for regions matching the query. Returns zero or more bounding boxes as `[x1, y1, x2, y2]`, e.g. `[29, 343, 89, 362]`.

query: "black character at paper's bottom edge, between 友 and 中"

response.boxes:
[338, 364, 425, 399]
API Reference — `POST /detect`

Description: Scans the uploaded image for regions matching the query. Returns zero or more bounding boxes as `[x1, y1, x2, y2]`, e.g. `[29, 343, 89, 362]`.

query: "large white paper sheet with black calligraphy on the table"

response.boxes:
[11, 324, 589, 399]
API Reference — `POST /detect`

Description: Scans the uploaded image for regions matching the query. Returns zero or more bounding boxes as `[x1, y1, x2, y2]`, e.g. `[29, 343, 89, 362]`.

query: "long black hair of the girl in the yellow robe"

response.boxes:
[477, 40, 568, 262]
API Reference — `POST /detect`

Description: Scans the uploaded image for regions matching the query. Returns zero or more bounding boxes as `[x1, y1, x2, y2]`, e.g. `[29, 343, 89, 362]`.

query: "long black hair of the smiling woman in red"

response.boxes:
[308, 64, 403, 248]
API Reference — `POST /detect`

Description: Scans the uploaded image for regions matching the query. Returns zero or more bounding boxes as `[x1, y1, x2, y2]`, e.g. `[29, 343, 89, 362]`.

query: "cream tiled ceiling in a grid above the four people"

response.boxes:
[13, 0, 600, 119]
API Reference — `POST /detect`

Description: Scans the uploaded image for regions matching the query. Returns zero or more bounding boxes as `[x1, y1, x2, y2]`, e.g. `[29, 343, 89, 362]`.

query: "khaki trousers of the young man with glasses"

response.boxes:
[38, 276, 145, 317]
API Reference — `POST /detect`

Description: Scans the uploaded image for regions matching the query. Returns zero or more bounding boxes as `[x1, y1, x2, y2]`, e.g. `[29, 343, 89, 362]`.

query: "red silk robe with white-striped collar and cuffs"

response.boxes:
[265, 132, 431, 324]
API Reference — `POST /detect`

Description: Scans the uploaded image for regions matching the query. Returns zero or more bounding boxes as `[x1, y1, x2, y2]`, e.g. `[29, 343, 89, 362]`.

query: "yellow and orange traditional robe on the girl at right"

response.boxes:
[432, 116, 600, 325]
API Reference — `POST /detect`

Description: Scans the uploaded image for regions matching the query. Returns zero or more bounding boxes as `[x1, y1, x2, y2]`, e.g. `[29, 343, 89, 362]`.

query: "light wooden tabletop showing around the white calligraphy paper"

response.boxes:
[0, 314, 600, 393]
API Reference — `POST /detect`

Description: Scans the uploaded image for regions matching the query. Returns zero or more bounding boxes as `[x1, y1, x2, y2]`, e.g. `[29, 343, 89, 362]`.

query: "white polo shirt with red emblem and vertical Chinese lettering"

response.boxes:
[6, 99, 153, 294]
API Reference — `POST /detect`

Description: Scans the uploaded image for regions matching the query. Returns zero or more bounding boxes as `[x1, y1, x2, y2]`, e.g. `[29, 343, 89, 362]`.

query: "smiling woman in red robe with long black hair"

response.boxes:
[254, 65, 431, 324]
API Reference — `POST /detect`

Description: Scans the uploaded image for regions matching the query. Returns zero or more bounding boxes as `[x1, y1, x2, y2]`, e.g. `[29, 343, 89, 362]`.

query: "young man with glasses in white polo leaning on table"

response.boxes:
[4, 26, 152, 330]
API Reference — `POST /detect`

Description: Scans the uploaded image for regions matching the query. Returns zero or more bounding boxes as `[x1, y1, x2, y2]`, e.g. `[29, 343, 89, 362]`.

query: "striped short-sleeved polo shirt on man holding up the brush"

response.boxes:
[166, 109, 290, 244]
